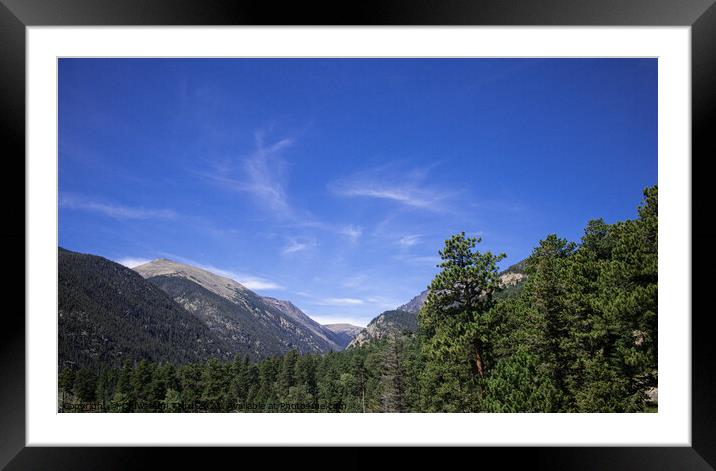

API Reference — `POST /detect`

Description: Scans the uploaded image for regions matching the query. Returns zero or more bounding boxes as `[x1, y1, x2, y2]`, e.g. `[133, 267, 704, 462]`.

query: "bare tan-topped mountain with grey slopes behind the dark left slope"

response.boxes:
[134, 259, 343, 358]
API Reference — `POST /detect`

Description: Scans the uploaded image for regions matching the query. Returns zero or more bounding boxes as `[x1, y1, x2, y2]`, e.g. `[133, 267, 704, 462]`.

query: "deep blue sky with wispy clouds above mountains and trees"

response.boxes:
[59, 59, 657, 325]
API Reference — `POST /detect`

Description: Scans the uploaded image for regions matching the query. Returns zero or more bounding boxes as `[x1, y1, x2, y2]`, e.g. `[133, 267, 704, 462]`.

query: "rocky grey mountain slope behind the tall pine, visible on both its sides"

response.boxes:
[346, 260, 527, 348]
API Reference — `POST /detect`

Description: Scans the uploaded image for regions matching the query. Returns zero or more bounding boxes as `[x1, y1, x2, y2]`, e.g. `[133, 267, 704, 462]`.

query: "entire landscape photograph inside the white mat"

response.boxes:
[58, 58, 656, 413]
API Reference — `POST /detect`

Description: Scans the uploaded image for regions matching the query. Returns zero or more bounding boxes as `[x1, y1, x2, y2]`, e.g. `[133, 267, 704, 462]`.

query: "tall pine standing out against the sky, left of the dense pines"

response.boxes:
[418, 233, 504, 412]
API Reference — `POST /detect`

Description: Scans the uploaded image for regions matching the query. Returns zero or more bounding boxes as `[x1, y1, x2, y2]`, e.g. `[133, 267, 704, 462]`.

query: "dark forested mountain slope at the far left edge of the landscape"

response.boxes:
[58, 248, 232, 367]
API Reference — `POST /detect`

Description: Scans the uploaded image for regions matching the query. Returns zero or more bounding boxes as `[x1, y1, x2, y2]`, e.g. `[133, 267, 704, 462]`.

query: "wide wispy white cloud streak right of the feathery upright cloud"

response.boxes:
[328, 167, 454, 211]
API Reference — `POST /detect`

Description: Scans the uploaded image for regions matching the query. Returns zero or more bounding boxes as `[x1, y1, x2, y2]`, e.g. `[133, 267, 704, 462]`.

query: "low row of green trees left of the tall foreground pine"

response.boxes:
[59, 340, 416, 412]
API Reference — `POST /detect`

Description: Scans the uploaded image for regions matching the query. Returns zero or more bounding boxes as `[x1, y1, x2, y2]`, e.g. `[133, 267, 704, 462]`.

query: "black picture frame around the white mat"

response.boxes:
[0, 0, 716, 470]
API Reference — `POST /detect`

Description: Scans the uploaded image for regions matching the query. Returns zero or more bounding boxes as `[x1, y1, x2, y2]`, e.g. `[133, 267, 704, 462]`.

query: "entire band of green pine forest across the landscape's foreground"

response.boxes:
[59, 187, 658, 412]
